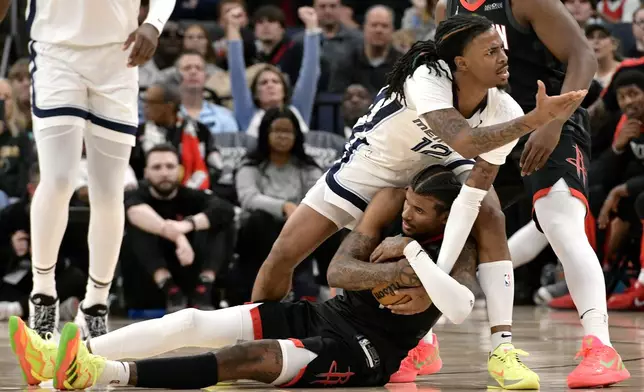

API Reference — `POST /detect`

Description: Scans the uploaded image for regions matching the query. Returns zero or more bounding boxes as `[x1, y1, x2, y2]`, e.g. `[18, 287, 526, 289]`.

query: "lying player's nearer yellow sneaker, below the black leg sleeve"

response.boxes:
[54, 323, 107, 390]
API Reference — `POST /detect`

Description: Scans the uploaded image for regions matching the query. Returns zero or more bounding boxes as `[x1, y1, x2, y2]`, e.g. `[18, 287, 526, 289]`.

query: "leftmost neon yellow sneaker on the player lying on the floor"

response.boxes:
[9, 316, 58, 385]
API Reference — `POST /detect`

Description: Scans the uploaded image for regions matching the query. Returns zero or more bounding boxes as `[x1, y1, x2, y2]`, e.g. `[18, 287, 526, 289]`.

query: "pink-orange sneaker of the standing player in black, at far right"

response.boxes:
[568, 335, 631, 388]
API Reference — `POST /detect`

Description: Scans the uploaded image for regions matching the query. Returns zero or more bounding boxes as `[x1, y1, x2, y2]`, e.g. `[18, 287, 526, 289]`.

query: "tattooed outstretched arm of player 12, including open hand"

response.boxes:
[420, 81, 587, 158]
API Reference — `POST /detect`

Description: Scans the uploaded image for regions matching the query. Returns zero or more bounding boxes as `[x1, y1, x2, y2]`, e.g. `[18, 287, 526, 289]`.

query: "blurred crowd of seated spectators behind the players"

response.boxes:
[0, 0, 644, 320]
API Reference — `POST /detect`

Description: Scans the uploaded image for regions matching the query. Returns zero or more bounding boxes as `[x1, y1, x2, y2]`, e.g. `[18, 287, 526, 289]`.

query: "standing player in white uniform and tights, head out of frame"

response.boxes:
[0, 0, 175, 337]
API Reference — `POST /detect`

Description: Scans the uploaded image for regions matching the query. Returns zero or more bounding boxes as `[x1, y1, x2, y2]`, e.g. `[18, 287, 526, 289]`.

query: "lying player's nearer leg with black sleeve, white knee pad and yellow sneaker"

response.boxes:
[54, 323, 317, 389]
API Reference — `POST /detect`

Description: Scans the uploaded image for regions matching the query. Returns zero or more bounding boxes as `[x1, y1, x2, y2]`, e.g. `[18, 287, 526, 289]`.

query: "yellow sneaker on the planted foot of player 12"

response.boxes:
[487, 343, 539, 389]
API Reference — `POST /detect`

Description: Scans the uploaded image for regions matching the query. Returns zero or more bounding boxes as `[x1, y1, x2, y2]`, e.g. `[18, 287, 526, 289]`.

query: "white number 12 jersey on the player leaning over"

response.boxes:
[341, 63, 523, 186]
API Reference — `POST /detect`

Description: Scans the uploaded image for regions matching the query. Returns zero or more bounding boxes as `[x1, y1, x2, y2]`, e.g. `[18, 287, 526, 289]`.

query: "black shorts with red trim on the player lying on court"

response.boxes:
[251, 301, 389, 388]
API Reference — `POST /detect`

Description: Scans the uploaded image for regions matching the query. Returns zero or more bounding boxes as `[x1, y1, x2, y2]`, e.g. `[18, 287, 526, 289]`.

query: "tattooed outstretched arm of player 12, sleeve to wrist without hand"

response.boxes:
[422, 108, 549, 159]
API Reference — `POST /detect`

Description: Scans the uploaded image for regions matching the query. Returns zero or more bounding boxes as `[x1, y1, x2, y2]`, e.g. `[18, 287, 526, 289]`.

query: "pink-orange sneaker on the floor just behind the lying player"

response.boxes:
[389, 334, 443, 383]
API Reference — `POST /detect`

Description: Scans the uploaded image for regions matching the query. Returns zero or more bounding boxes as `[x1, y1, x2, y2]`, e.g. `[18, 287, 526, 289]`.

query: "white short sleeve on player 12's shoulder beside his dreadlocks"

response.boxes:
[405, 65, 454, 116]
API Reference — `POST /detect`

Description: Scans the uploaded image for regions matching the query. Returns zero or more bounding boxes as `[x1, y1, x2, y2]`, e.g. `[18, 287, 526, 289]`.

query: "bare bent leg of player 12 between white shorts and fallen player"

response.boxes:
[252, 203, 339, 302]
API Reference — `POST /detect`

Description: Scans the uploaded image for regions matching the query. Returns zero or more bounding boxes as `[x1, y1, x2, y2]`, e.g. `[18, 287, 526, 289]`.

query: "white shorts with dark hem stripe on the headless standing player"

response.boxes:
[29, 41, 139, 146]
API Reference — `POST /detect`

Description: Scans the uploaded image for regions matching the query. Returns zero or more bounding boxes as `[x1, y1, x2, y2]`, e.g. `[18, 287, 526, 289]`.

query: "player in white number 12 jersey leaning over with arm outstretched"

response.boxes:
[252, 12, 584, 388]
